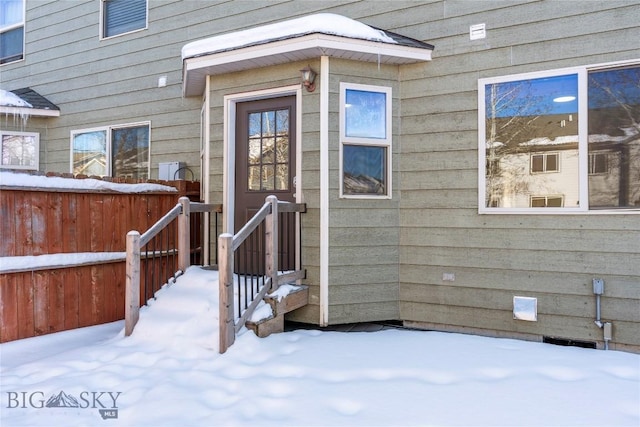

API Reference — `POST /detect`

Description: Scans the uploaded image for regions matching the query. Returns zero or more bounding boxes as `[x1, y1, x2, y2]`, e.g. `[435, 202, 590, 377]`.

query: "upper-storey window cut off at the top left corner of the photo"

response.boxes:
[0, 0, 25, 64]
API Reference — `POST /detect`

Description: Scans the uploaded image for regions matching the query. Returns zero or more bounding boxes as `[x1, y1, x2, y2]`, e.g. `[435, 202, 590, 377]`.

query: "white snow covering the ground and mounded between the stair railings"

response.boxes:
[0, 267, 640, 427]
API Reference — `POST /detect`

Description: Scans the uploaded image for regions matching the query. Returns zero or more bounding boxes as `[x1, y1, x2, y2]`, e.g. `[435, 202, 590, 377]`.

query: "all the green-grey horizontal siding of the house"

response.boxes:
[0, 0, 640, 350]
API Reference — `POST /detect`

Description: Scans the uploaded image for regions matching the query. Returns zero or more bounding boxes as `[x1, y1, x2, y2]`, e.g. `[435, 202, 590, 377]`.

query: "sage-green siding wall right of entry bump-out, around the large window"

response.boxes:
[396, 1, 640, 350]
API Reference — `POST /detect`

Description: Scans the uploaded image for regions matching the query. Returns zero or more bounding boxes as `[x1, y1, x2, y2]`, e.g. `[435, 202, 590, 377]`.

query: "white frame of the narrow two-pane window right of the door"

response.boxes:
[338, 82, 393, 200]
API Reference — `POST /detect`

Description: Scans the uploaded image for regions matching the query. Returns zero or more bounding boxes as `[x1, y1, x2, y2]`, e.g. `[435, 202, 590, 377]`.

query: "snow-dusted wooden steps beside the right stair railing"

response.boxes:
[245, 285, 309, 338]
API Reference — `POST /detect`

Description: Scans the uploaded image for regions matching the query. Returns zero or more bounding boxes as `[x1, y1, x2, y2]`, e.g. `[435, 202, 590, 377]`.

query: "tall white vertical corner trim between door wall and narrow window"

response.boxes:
[320, 55, 329, 326]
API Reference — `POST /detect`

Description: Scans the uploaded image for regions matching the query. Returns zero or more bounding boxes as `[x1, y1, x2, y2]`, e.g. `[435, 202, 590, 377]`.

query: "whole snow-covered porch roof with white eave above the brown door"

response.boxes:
[182, 13, 433, 96]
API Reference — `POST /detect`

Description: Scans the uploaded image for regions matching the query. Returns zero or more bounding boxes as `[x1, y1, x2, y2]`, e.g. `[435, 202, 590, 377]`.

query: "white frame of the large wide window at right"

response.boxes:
[477, 58, 640, 215]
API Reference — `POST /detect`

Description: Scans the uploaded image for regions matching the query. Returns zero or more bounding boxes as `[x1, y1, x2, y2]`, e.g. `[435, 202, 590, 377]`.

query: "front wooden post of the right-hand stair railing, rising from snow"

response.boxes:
[218, 233, 236, 354]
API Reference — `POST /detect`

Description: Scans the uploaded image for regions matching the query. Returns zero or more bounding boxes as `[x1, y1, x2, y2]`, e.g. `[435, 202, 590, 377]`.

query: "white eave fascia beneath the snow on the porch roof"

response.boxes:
[182, 33, 432, 97]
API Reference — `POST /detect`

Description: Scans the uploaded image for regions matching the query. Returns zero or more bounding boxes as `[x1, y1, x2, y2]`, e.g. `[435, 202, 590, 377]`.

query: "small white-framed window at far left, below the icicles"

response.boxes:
[0, 130, 40, 170]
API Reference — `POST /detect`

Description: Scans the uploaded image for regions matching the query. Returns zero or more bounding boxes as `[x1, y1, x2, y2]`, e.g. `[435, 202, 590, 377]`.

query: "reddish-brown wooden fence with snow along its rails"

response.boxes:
[0, 181, 199, 342]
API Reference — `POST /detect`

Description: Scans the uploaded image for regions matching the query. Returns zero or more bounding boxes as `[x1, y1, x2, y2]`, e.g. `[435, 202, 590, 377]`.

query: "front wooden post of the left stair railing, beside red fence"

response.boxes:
[124, 231, 140, 336]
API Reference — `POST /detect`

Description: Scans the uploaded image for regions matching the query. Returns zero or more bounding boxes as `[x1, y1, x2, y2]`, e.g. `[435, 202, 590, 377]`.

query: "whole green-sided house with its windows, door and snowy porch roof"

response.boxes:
[0, 0, 640, 351]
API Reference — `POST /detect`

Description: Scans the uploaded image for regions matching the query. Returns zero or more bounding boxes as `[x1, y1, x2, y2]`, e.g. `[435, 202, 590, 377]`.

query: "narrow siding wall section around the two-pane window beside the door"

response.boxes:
[328, 58, 401, 324]
